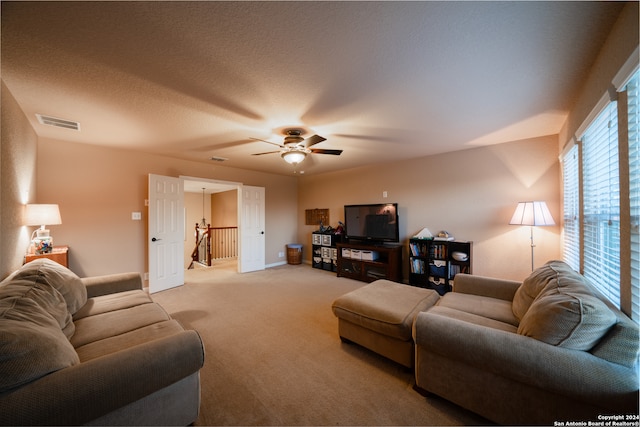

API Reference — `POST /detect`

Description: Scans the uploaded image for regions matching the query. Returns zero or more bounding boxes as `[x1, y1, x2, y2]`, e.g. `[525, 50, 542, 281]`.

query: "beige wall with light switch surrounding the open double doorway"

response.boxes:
[37, 139, 297, 276]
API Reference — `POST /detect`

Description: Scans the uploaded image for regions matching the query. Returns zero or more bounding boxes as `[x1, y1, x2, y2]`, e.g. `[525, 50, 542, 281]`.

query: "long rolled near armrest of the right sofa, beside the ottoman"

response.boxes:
[413, 311, 638, 408]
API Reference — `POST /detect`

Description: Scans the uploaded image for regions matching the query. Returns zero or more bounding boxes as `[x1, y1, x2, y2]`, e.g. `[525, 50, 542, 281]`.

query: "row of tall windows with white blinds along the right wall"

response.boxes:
[561, 66, 640, 322]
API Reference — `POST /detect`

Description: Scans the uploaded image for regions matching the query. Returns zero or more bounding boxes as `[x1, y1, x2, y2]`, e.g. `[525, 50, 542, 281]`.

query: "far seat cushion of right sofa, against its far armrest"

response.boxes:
[437, 292, 519, 327]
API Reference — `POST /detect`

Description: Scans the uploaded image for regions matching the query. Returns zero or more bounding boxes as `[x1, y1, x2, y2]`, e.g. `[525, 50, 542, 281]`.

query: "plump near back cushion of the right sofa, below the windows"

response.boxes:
[518, 261, 616, 351]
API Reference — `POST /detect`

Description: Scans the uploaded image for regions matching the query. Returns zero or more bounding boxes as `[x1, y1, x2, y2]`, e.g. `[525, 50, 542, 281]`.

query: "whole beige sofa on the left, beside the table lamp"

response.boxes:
[0, 259, 204, 425]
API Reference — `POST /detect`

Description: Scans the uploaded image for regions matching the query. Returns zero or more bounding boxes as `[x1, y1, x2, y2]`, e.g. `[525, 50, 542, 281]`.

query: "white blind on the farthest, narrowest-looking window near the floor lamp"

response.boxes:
[562, 145, 580, 271]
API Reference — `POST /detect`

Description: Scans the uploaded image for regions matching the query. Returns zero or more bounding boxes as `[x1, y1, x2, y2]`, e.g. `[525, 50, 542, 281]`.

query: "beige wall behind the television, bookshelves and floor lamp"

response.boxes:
[298, 136, 560, 279]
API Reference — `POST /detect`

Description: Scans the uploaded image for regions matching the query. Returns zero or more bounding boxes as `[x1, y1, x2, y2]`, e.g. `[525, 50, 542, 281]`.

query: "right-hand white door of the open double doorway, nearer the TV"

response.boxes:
[238, 185, 265, 273]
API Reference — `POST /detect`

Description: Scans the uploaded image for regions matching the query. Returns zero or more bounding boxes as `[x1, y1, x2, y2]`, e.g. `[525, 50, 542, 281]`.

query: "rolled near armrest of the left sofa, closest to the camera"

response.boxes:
[0, 331, 204, 425]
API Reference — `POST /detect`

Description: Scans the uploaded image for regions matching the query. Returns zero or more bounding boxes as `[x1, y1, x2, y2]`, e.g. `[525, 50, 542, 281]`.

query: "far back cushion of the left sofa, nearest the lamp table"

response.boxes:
[14, 258, 87, 315]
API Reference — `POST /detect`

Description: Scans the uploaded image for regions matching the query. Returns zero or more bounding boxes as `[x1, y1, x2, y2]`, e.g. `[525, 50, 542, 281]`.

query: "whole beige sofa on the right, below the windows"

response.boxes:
[413, 261, 639, 425]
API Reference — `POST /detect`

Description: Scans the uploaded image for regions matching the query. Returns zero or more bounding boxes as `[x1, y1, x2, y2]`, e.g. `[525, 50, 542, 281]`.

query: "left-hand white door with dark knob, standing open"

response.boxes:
[148, 174, 184, 293]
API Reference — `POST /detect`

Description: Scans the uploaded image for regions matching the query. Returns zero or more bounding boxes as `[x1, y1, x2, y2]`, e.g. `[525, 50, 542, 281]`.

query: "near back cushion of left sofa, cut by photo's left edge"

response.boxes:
[0, 285, 80, 393]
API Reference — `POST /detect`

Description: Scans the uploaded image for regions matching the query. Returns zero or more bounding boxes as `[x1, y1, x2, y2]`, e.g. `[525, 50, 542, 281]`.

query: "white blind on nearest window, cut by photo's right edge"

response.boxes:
[627, 71, 640, 322]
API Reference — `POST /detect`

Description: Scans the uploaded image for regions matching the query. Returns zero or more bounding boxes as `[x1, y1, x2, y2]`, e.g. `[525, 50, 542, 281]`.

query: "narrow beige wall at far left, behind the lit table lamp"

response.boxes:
[0, 82, 38, 279]
